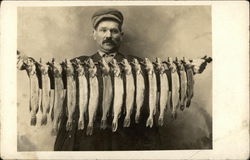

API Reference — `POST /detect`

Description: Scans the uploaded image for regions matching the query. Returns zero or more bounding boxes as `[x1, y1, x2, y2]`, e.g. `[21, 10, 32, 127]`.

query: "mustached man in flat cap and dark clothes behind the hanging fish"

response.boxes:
[54, 9, 159, 150]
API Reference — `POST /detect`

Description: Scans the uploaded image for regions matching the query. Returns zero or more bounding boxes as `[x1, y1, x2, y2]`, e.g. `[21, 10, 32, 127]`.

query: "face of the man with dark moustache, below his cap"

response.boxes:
[93, 20, 123, 53]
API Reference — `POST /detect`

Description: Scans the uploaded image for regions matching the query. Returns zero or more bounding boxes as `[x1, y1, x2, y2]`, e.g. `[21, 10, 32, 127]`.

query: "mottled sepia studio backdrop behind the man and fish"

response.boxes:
[17, 6, 212, 151]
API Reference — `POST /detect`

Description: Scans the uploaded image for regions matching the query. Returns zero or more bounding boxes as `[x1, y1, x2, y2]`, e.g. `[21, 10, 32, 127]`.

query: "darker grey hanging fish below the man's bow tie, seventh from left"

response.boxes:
[99, 57, 113, 129]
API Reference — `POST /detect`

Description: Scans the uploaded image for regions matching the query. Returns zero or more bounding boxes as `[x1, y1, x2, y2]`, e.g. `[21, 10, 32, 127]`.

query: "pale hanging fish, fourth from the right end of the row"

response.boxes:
[155, 58, 169, 126]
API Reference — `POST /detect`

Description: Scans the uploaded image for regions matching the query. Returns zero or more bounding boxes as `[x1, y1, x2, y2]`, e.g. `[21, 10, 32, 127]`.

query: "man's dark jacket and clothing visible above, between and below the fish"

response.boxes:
[54, 53, 160, 151]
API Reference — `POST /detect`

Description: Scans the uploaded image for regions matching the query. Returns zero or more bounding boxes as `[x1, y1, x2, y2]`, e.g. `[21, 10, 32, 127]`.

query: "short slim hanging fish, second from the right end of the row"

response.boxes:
[175, 58, 187, 110]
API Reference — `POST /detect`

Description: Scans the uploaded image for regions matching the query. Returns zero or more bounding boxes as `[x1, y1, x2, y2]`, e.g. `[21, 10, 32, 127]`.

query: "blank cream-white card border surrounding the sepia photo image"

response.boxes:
[0, 1, 249, 159]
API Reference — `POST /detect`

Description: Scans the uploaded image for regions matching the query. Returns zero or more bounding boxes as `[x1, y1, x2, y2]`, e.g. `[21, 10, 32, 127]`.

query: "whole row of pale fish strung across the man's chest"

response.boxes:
[17, 50, 212, 135]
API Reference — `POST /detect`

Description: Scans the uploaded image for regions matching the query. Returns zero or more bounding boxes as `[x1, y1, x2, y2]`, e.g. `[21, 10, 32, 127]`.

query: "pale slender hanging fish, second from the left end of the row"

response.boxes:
[37, 59, 50, 125]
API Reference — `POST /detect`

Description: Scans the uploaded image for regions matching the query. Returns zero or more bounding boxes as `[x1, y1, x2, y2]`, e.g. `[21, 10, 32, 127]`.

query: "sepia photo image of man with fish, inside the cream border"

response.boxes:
[17, 5, 212, 151]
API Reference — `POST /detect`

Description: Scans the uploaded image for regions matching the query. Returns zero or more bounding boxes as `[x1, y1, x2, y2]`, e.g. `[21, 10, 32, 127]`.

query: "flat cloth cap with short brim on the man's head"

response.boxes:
[91, 8, 123, 28]
